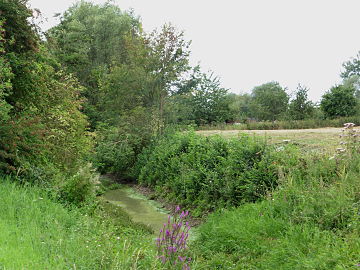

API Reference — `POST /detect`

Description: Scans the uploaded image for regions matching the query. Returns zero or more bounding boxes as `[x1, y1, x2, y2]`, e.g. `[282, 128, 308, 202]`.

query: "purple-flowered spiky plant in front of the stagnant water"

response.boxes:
[156, 206, 191, 270]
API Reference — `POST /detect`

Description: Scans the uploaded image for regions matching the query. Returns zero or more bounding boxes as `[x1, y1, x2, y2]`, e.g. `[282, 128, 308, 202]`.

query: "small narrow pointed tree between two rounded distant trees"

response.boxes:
[288, 84, 314, 120]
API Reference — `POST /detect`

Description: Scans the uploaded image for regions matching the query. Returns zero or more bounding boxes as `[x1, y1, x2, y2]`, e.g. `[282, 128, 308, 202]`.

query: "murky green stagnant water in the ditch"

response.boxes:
[104, 187, 168, 234]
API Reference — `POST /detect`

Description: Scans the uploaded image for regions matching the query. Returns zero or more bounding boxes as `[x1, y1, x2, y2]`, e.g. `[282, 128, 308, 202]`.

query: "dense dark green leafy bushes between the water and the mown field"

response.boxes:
[135, 132, 291, 214]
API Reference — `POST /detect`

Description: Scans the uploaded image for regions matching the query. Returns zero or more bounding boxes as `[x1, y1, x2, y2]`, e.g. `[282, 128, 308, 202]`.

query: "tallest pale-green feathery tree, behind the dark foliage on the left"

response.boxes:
[46, 1, 141, 128]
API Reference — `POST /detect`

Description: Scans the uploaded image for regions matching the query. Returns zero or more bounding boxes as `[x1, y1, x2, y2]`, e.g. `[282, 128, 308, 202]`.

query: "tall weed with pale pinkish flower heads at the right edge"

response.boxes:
[336, 123, 360, 155]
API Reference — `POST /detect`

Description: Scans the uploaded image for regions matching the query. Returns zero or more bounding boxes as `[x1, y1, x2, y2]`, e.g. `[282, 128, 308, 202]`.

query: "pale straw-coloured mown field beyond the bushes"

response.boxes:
[196, 128, 341, 153]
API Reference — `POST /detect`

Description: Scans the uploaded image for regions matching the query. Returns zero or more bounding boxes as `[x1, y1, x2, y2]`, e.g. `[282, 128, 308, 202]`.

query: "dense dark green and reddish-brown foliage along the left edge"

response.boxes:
[0, 1, 94, 206]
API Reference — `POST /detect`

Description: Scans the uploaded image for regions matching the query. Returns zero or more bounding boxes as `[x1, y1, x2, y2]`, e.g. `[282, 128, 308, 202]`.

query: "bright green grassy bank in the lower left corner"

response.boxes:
[0, 178, 161, 270]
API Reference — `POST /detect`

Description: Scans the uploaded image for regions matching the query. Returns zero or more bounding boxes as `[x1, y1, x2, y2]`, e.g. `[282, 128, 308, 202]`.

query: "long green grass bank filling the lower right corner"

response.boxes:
[192, 151, 360, 269]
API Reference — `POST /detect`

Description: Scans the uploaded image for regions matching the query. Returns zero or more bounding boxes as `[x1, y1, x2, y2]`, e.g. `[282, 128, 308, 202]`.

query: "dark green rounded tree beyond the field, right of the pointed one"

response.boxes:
[320, 85, 358, 118]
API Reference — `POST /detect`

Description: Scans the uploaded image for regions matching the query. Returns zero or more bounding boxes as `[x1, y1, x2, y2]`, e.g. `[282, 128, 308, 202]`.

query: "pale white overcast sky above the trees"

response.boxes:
[29, 0, 360, 101]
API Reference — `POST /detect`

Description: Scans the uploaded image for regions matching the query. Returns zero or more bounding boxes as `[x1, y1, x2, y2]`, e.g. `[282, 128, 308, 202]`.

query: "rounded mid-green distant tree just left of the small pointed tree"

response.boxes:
[251, 82, 289, 121]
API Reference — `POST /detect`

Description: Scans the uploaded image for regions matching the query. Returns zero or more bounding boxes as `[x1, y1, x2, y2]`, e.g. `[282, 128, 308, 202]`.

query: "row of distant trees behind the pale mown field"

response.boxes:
[177, 76, 360, 127]
